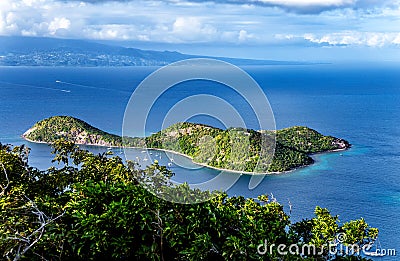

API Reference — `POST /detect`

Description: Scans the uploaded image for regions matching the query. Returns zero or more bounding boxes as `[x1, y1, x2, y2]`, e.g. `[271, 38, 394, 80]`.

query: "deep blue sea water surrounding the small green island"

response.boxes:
[0, 64, 400, 260]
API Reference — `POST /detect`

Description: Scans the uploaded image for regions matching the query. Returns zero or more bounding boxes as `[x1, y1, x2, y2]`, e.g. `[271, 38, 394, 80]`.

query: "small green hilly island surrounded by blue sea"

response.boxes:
[22, 116, 351, 174]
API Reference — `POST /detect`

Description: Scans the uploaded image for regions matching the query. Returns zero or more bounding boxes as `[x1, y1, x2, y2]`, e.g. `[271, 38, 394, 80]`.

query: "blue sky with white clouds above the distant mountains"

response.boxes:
[0, 0, 400, 61]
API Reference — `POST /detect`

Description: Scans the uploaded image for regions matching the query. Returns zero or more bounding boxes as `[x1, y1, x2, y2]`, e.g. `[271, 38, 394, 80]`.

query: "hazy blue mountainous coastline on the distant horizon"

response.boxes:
[0, 36, 304, 67]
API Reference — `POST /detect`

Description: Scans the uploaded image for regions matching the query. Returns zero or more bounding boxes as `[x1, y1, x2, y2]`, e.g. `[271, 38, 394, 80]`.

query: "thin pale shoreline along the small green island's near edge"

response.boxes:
[21, 133, 351, 176]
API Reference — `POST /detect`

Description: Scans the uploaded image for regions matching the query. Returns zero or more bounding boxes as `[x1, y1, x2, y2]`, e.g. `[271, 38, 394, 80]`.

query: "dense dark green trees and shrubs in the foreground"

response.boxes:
[0, 140, 378, 260]
